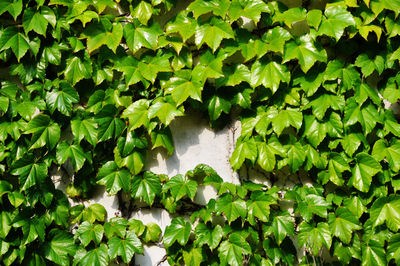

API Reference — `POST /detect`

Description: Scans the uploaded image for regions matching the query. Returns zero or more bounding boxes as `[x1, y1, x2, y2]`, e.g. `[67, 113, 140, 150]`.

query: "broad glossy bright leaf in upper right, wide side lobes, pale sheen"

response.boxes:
[283, 35, 327, 73]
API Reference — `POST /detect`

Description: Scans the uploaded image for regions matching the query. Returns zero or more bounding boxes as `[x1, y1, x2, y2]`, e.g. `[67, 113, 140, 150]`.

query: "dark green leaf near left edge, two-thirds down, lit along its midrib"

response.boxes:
[10, 155, 47, 190]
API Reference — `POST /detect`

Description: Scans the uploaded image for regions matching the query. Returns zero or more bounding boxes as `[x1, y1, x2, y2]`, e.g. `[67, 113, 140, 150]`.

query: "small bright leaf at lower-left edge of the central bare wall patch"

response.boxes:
[164, 174, 197, 201]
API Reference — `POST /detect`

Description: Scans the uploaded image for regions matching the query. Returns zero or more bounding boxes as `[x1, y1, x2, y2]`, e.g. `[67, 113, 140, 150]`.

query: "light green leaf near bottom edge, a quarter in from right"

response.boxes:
[298, 222, 332, 255]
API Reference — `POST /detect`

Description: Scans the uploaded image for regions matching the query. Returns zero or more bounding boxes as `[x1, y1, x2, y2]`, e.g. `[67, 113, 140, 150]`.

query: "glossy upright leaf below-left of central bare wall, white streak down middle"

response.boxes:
[132, 171, 161, 206]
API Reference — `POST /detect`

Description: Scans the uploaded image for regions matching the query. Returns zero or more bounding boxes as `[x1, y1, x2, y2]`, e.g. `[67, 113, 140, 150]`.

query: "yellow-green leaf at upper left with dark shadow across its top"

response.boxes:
[83, 19, 123, 53]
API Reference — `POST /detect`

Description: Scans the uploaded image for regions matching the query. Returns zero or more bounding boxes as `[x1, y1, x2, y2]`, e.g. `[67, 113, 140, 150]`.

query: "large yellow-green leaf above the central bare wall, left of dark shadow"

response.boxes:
[165, 69, 203, 106]
